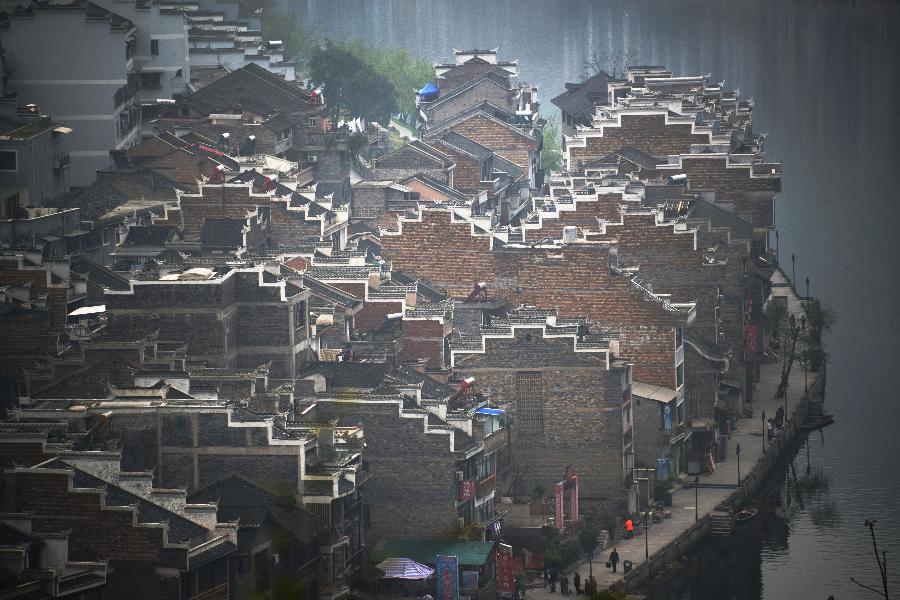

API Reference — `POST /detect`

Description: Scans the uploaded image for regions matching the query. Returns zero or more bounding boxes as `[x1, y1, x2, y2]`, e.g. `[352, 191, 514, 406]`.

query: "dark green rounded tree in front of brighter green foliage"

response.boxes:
[310, 40, 397, 125]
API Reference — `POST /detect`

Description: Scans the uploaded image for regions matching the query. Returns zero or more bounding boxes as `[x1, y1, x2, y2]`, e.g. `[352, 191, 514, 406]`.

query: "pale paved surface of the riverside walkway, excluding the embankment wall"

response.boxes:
[527, 271, 812, 600]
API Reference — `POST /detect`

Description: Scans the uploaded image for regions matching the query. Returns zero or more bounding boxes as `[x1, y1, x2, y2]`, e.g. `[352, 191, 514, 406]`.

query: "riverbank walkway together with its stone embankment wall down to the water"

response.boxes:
[529, 271, 824, 600]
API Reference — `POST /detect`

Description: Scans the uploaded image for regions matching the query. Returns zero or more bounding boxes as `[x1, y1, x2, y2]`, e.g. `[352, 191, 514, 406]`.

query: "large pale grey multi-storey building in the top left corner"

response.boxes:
[0, 0, 141, 186]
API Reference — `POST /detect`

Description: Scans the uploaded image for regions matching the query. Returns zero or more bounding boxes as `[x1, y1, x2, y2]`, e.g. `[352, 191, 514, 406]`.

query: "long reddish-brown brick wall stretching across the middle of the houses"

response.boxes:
[382, 210, 686, 387]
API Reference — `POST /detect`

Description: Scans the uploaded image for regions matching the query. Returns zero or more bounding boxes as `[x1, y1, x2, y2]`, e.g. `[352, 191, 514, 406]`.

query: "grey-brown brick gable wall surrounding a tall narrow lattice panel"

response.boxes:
[456, 329, 627, 502]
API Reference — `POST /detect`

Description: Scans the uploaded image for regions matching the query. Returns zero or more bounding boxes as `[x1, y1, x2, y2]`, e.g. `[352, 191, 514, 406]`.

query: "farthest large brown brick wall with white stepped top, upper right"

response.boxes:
[567, 114, 710, 169]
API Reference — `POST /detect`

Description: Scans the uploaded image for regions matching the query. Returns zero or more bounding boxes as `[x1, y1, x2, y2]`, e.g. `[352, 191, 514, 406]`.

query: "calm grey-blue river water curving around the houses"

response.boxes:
[282, 0, 900, 600]
